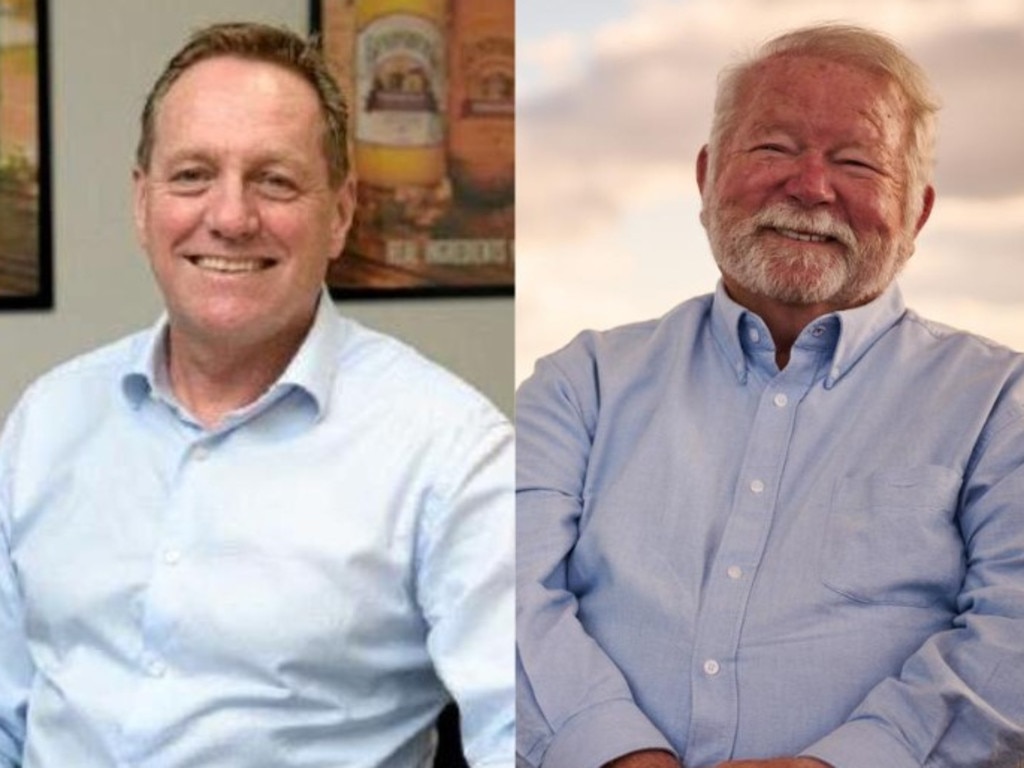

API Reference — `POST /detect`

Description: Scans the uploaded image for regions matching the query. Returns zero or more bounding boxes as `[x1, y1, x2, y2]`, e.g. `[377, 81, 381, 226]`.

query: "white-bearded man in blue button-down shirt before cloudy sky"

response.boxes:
[516, 25, 1024, 768]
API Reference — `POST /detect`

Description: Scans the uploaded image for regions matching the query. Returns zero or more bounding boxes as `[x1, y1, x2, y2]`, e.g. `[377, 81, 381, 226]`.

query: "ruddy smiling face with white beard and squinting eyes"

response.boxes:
[697, 55, 932, 311]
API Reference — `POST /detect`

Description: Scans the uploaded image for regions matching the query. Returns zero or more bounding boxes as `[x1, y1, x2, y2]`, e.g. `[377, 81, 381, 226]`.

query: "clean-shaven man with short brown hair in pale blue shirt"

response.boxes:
[0, 24, 513, 768]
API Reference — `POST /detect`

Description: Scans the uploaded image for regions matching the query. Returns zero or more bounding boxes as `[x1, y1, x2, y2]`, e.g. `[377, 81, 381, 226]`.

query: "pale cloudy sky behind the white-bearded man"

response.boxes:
[516, 0, 1024, 380]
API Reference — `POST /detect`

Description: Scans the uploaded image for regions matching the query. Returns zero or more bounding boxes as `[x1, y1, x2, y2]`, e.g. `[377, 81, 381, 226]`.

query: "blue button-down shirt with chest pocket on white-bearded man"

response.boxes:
[516, 286, 1024, 768]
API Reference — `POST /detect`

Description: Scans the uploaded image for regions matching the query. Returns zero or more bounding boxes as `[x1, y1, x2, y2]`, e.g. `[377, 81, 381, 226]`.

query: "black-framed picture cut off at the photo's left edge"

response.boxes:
[0, 0, 53, 309]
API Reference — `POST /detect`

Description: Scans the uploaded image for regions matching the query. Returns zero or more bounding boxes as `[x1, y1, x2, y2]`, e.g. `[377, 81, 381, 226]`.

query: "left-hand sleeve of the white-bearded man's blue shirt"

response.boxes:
[516, 344, 673, 768]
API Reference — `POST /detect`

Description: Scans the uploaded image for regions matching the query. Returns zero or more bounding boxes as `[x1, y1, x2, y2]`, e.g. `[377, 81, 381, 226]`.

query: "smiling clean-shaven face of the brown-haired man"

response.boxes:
[134, 56, 353, 354]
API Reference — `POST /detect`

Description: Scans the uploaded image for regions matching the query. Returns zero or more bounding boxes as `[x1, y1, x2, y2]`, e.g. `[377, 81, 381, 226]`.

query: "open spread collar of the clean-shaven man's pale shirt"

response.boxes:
[121, 287, 345, 419]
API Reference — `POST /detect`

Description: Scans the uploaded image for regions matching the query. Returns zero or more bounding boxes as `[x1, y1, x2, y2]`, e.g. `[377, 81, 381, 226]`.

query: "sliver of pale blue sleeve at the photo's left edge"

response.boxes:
[0, 405, 35, 768]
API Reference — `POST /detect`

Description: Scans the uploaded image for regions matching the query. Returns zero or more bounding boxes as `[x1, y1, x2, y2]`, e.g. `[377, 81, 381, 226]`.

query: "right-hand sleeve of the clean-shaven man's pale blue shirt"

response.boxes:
[417, 406, 515, 768]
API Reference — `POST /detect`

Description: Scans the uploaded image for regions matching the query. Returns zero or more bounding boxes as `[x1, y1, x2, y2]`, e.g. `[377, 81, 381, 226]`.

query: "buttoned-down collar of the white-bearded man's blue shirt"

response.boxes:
[711, 281, 906, 389]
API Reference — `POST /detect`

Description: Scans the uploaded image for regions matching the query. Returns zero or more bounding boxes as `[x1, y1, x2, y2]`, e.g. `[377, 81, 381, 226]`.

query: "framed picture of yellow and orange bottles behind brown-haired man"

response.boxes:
[310, 0, 515, 298]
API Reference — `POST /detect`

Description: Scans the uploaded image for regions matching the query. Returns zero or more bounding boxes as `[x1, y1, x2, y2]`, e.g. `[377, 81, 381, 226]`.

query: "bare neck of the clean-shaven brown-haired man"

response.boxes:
[161, 325, 308, 429]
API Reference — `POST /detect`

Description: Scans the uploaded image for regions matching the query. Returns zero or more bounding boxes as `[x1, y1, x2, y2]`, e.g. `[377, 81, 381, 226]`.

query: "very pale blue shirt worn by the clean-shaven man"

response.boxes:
[0, 290, 514, 768]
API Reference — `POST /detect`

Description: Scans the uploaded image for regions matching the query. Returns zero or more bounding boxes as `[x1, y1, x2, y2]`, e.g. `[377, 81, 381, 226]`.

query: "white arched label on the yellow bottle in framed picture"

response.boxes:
[355, 13, 446, 146]
